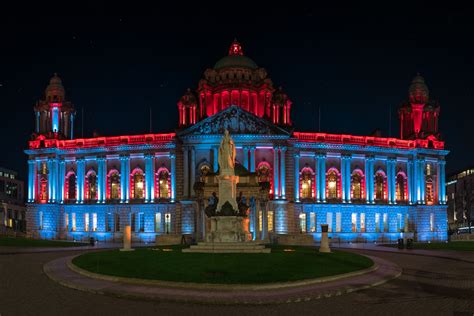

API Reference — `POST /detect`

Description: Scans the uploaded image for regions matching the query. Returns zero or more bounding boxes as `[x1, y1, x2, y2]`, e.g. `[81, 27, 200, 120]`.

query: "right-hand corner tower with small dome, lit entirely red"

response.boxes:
[398, 74, 440, 140]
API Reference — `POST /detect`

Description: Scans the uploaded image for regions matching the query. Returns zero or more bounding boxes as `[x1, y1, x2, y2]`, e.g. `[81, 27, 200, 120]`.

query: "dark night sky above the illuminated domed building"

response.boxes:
[0, 1, 474, 180]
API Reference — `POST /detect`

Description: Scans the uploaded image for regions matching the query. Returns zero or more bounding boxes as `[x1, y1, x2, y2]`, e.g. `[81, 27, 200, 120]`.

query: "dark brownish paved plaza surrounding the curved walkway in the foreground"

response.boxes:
[0, 248, 474, 316]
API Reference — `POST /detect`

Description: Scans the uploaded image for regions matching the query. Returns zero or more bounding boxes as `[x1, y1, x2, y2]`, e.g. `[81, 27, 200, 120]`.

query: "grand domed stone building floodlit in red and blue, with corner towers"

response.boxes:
[26, 41, 448, 241]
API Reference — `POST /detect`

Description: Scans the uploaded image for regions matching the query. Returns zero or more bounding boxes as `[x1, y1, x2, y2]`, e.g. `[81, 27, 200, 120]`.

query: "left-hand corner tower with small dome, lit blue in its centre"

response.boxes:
[34, 73, 75, 139]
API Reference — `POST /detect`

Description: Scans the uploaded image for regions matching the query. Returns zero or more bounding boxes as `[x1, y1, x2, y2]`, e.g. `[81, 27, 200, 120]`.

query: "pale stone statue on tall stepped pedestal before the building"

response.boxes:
[183, 130, 270, 253]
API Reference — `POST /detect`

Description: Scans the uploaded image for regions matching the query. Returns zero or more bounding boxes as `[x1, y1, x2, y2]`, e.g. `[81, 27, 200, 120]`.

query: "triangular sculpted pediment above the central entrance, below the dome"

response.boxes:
[177, 105, 291, 137]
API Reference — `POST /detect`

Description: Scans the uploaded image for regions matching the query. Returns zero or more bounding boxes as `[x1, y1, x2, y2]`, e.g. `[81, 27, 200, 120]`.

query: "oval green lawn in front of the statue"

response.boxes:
[73, 246, 373, 284]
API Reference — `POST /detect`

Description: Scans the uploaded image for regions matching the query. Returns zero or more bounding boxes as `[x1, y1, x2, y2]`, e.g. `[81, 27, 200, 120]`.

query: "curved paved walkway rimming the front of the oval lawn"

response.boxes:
[43, 256, 401, 305]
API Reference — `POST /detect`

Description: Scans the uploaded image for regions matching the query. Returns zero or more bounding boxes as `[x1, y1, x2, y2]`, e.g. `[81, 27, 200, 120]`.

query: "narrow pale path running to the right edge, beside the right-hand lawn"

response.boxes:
[330, 243, 474, 263]
